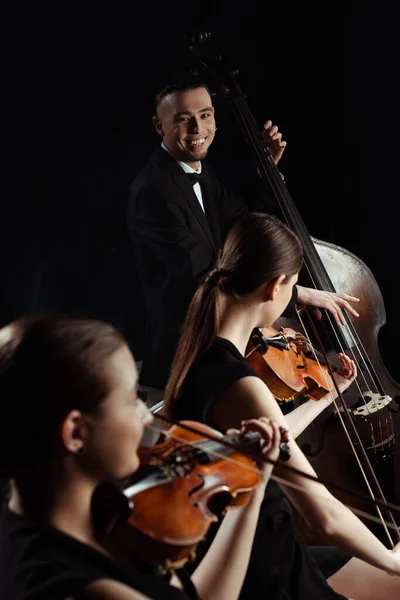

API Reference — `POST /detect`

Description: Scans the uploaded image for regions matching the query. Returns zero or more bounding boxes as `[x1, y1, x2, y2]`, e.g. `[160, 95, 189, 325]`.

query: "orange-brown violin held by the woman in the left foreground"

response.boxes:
[100, 421, 290, 571]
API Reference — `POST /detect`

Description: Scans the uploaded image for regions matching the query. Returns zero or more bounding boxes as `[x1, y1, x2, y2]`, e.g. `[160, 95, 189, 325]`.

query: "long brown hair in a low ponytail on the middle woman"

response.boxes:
[164, 213, 303, 416]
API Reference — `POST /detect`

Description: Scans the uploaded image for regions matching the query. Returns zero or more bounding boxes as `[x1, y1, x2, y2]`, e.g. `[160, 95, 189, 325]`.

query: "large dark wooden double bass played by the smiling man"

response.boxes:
[189, 34, 400, 544]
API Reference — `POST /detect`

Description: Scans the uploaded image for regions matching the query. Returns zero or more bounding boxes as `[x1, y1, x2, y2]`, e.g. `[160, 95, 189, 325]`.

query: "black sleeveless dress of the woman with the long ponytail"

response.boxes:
[174, 337, 351, 600]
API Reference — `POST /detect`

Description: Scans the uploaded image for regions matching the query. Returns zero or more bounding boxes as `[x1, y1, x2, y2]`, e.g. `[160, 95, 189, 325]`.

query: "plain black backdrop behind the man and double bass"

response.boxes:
[0, 0, 400, 379]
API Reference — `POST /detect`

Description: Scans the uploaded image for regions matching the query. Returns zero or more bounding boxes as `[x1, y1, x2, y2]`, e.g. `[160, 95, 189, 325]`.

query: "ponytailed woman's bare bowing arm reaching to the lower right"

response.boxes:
[210, 377, 400, 575]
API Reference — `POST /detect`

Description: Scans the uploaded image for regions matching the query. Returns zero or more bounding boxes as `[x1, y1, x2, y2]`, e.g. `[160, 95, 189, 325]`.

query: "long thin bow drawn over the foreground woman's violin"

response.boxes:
[143, 415, 400, 531]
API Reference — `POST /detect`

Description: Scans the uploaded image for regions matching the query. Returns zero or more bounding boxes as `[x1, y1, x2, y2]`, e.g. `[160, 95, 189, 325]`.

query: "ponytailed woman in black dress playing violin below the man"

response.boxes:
[163, 213, 400, 600]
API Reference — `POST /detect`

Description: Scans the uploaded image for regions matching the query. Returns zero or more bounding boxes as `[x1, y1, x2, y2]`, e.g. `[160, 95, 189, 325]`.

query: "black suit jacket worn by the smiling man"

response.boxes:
[128, 147, 293, 389]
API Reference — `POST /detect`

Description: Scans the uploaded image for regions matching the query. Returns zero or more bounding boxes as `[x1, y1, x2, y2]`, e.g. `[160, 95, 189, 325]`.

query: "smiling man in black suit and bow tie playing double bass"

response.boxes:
[128, 77, 356, 390]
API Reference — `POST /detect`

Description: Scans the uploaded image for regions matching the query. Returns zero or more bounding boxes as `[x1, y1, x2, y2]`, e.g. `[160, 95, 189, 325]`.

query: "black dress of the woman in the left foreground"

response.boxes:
[0, 506, 187, 600]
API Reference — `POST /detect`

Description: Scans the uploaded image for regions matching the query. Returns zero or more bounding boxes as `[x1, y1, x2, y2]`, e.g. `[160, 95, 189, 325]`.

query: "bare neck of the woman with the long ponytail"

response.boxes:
[218, 298, 259, 356]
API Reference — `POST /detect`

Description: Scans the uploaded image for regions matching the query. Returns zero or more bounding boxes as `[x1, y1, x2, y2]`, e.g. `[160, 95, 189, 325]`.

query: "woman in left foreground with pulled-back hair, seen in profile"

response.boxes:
[0, 315, 281, 600]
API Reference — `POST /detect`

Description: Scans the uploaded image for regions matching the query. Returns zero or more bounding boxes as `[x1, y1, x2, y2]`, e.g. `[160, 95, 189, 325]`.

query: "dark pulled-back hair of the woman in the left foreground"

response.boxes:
[0, 315, 125, 477]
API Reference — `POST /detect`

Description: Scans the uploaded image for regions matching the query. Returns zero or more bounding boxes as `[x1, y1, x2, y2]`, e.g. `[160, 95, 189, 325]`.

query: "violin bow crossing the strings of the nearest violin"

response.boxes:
[147, 417, 400, 539]
